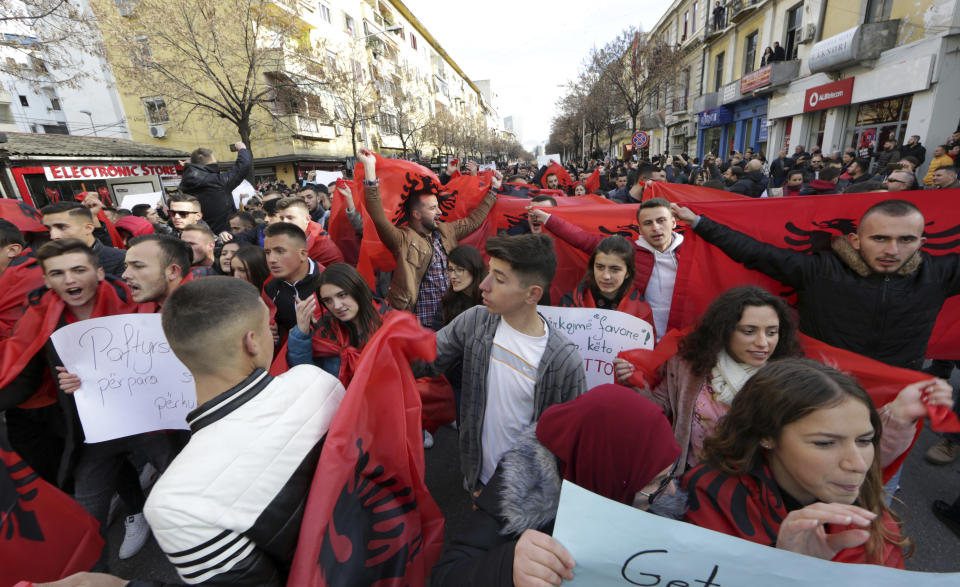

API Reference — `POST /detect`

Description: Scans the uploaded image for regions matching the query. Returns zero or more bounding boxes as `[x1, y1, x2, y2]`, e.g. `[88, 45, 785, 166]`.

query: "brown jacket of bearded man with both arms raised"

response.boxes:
[364, 185, 497, 312]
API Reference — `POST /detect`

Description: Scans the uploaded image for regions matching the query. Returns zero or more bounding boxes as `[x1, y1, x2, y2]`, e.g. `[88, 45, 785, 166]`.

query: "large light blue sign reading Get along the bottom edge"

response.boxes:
[553, 481, 960, 587]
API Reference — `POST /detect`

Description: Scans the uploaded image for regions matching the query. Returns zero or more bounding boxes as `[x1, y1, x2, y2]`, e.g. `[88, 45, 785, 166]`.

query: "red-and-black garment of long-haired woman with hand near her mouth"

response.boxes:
[682, 463, 903, 569]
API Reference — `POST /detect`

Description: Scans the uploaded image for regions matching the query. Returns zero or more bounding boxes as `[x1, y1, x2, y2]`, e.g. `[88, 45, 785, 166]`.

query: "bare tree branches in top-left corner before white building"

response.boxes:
[0, 0, 103, 87]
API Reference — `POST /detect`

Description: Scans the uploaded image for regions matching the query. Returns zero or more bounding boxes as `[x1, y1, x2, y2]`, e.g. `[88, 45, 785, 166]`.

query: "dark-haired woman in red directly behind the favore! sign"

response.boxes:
[560, 236, 653, 327]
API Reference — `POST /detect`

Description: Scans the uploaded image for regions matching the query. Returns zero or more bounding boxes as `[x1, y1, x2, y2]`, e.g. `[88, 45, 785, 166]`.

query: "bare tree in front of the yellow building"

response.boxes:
[95, 0, 323, 145]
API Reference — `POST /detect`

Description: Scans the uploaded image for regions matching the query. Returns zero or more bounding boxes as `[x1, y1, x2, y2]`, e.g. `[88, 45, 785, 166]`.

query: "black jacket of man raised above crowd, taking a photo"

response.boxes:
[180, 149, 253, 234]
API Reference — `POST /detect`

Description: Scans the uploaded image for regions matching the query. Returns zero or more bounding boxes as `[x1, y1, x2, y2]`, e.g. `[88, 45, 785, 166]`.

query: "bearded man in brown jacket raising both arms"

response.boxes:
[357, 149, 503, 328]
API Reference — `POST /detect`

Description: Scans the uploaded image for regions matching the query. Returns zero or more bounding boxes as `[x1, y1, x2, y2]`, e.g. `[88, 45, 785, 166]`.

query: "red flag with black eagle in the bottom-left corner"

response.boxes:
[0, 430, 103, 585]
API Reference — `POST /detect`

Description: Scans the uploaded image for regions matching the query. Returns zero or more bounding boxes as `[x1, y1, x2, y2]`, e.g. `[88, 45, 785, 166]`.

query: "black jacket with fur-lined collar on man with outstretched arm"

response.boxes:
[694, 216, 960, 369]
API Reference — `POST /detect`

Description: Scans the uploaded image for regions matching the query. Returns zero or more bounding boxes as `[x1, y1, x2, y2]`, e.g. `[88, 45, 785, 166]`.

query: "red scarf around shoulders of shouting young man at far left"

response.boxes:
[0, 277, 144, 409]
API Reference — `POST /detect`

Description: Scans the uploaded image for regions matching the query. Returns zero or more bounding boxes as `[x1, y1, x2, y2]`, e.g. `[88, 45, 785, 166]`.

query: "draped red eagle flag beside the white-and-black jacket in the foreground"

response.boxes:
[287, 312, 444, 587]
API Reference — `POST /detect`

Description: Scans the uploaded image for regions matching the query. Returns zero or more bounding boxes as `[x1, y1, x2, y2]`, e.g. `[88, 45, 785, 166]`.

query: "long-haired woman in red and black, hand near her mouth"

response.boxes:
[683, 359, 911, 568]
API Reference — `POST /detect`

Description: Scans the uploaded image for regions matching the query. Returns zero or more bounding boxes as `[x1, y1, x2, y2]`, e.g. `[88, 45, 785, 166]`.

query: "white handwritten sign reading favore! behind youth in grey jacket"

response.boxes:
[537, 306, 654, 389]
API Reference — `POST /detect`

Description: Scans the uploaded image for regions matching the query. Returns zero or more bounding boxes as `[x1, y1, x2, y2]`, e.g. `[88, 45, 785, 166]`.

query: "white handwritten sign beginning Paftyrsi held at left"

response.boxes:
[50, 314, 197, 442]
